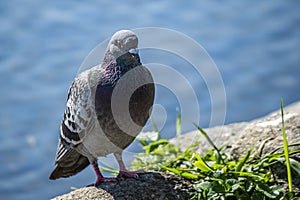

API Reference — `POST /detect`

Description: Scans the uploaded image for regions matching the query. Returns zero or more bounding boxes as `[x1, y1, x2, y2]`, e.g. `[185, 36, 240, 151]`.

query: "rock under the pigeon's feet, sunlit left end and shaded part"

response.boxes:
[51, 172, 193, 200]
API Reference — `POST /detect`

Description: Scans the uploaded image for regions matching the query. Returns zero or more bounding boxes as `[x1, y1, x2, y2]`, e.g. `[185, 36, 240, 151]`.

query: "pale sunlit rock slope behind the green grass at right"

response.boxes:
[170, 102, 300, 157]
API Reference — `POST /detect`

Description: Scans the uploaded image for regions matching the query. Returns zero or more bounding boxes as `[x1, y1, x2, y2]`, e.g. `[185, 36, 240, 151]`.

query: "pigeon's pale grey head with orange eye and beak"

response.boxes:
[107, 30, 138, 59]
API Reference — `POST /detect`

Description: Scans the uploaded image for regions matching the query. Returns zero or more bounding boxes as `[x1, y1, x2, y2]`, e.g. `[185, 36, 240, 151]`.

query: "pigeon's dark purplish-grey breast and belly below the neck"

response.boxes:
[86, 66, 154, 157]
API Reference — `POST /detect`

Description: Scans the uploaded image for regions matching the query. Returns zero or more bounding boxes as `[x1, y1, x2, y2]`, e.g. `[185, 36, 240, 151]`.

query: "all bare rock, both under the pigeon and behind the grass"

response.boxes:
[55, 102, 300, 200]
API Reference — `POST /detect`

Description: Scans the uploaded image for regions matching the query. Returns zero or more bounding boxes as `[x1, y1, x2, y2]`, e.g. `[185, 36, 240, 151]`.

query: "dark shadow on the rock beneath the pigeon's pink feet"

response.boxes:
[92, 172, 193, 200]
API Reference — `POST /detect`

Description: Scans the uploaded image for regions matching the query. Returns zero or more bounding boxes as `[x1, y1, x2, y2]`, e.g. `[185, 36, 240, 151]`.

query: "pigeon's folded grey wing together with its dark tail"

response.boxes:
[49, 70, 99, 180]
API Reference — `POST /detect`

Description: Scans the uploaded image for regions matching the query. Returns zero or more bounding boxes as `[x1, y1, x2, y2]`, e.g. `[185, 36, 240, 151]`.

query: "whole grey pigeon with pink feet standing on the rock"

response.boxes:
[49, 30, 155, 185]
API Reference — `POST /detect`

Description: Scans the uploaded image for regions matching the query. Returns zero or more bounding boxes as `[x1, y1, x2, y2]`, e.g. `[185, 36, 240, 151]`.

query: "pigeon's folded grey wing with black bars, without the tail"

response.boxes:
[56, 72, 94, 163]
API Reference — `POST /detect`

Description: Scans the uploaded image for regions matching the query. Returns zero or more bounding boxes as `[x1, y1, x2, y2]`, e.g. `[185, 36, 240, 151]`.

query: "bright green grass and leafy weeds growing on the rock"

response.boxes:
[132, 103, 300, 200]
